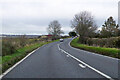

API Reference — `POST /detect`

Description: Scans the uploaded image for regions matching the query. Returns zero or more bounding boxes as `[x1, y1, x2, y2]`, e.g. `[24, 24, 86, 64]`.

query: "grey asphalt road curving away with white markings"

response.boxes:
[3, 38, 118, 80]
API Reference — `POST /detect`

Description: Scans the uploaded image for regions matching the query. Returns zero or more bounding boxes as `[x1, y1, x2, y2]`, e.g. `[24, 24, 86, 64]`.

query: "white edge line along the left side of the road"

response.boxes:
[0, 44, 46, 80]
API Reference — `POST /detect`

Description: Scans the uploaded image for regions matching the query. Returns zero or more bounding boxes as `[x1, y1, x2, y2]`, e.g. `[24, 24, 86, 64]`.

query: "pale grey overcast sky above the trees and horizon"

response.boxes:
[0, 0, 119, 34]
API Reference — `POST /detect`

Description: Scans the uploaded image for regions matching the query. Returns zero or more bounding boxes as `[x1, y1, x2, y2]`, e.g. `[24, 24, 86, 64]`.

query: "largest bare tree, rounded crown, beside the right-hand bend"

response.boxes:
[71, 11, 97, 43]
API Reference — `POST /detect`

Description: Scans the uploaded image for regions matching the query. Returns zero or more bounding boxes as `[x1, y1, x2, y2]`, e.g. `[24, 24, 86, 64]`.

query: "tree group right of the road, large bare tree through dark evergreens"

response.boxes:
[71, 11, 120, 44]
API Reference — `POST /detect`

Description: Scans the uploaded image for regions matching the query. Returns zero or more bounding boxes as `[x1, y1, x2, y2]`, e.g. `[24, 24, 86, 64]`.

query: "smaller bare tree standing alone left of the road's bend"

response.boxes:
[47, 20, 64, 38]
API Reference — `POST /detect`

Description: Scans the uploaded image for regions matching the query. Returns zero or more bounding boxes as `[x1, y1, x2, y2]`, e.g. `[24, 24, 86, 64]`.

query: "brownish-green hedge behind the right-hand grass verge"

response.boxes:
[86, 37, 120, 48]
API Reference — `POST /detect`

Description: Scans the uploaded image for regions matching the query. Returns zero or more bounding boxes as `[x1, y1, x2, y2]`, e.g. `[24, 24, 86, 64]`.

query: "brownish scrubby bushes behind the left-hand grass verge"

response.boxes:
[2, 37, 40, 56]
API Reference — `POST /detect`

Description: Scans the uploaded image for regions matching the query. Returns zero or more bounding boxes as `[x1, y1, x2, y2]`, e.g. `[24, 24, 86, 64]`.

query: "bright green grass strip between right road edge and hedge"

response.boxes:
[71, 38, 120, 59]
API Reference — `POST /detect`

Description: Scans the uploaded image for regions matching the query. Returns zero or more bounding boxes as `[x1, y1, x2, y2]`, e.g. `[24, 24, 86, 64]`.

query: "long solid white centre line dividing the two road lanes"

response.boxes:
[58, 44, 114, 80]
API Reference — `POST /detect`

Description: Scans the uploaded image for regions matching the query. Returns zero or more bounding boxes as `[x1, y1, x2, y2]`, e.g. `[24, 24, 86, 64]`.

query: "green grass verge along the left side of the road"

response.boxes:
[0, 40, 58, 72]
